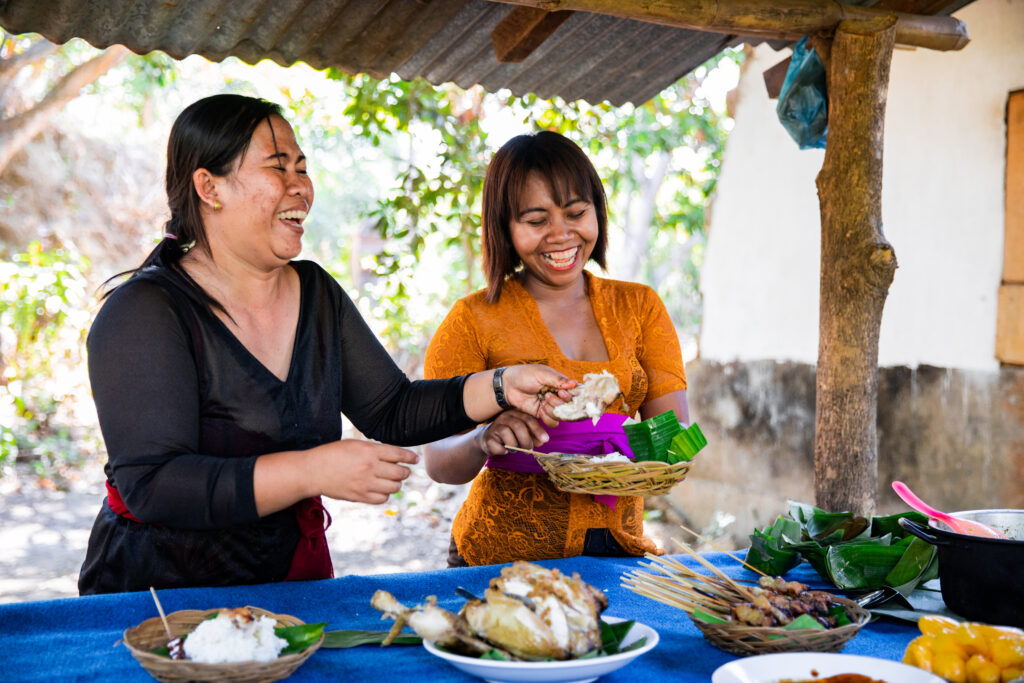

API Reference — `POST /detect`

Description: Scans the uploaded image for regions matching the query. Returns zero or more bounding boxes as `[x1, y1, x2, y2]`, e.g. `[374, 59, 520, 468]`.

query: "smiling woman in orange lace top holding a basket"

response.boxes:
[425, 131, 689, 566]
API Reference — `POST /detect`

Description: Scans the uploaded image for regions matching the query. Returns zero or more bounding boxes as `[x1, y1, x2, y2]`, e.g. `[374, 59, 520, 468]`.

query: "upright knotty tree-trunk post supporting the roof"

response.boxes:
[814, 18, 896, 515]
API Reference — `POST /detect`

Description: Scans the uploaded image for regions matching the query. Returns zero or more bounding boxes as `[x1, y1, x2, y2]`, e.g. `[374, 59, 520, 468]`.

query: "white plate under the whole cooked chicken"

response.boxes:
[423, 616, 657, 683]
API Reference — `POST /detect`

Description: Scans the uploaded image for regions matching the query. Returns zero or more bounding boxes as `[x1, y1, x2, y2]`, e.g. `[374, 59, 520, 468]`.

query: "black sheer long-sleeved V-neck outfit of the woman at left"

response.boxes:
[79, 261, 473, 594]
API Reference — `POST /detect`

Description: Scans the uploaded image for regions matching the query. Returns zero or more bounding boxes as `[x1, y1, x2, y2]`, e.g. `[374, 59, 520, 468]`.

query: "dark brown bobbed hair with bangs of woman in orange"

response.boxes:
[480, 130, 608, 303]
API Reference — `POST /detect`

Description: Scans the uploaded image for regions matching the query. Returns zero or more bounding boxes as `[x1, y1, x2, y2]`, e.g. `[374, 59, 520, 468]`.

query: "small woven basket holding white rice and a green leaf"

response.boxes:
[124, 607, 324, 683]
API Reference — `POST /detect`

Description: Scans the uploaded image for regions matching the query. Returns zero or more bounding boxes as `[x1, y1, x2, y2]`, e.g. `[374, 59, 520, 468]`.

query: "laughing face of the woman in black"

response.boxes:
[207, 116, 313, 267]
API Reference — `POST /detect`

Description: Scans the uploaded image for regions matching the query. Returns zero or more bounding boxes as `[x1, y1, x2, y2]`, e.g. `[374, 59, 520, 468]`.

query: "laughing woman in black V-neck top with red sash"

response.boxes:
[79, 95, 573, 595]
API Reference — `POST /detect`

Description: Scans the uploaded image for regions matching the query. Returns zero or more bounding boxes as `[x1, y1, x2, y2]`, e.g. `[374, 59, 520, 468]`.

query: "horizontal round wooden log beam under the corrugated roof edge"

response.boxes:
[493, 0, 969, 50]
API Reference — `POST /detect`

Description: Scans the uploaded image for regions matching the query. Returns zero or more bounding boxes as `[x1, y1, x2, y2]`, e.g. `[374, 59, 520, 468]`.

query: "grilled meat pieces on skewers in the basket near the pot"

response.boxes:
[729, 577, 849, 629]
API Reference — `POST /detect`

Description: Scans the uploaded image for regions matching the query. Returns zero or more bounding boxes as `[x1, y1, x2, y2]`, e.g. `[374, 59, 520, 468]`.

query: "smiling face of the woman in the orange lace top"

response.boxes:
[509, 171, 598, 289]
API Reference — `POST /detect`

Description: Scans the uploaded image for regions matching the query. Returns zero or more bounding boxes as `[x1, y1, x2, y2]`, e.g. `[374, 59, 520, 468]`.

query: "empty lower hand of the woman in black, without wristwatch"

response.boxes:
[310, 439, 420, 505]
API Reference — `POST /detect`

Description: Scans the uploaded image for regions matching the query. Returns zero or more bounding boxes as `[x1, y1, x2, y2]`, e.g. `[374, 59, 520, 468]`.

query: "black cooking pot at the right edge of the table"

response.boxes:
[899, 510, 1024, 627]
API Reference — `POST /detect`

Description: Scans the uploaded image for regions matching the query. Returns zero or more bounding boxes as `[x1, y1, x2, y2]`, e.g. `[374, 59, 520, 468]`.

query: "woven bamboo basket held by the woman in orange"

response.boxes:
[509, 449, 692, 496]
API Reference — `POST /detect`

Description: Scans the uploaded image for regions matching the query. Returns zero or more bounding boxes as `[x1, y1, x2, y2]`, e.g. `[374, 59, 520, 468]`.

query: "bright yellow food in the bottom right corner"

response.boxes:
[903, 614, 1024, 683]
